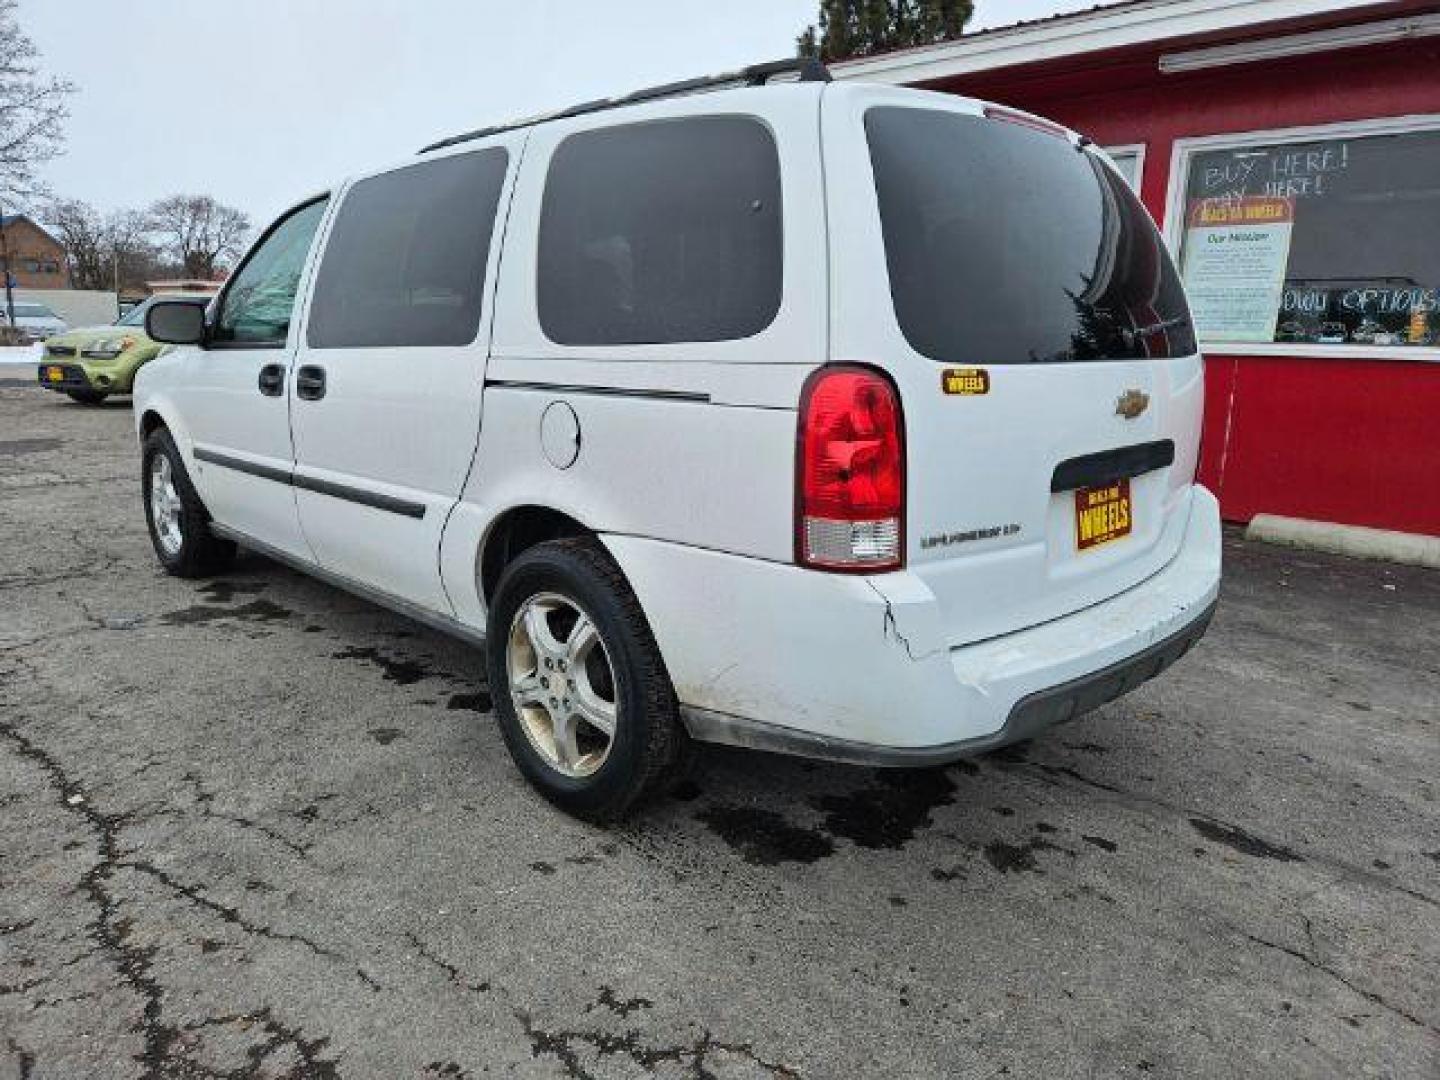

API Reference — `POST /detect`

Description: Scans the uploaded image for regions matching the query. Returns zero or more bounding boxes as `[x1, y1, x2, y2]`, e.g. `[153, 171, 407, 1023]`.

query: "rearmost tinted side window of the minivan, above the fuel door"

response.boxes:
[537, 117, 783, 346]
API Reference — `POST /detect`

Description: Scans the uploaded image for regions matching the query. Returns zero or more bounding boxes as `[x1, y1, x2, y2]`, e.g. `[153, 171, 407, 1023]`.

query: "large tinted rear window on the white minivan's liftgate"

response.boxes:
[865, 108, 1195, 364]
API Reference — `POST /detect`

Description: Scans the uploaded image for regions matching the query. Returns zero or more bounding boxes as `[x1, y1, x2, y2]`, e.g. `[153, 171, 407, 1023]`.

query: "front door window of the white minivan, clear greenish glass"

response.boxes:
[213, 199, 328, 346]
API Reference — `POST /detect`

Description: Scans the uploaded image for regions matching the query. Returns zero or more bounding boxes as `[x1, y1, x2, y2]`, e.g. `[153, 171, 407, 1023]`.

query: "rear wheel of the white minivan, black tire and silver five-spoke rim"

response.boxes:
[487, 537, 687, 821]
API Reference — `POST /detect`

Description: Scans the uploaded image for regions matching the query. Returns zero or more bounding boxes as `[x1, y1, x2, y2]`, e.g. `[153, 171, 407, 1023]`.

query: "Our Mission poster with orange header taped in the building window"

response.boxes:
[1182, 196, 1295, 341]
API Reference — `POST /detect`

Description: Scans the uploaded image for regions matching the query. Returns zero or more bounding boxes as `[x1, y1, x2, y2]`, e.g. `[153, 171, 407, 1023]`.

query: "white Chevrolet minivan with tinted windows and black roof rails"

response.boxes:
[135, 63, 1221, 819]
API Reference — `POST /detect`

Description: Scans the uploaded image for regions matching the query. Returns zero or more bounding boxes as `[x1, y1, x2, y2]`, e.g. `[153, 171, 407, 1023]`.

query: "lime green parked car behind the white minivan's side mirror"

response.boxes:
[39, 294, 210, 405]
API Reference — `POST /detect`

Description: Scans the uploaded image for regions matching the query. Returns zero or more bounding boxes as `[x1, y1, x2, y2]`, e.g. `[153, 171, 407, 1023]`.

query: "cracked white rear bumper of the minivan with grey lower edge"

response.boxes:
[606, 488, 1221, 765]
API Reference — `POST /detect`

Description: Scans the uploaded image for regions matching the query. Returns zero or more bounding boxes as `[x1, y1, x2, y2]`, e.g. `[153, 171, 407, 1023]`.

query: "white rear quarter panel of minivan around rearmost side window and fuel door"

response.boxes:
[442, 85, 828, 622]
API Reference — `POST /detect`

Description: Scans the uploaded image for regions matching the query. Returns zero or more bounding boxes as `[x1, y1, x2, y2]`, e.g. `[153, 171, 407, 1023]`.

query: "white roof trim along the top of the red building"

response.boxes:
[829, 0, 1377, 86]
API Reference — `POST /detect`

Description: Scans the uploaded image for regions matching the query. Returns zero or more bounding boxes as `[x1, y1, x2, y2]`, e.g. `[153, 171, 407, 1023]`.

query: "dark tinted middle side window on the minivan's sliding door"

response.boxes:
[307, 147, 510, 348]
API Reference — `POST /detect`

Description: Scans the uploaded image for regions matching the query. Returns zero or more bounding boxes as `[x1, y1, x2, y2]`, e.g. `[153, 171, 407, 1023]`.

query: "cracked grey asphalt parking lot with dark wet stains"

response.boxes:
[0, 372, 1440, 1080]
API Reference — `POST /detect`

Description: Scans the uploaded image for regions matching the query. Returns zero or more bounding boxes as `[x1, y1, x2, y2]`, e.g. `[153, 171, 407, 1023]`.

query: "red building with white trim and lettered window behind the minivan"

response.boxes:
[834, 0, 1440, 536]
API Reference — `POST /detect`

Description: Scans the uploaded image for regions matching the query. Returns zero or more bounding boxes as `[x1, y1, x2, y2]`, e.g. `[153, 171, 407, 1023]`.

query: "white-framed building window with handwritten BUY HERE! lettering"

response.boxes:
[1171, 124, 1440, 353]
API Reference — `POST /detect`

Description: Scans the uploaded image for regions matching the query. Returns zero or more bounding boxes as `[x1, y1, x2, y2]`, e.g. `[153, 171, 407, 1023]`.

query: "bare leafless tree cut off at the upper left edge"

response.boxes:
[0, 0, 75, 204]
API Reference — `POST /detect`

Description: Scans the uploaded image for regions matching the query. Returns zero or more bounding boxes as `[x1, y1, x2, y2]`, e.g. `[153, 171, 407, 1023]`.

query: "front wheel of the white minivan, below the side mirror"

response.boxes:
[141, 428, 235, 577]
